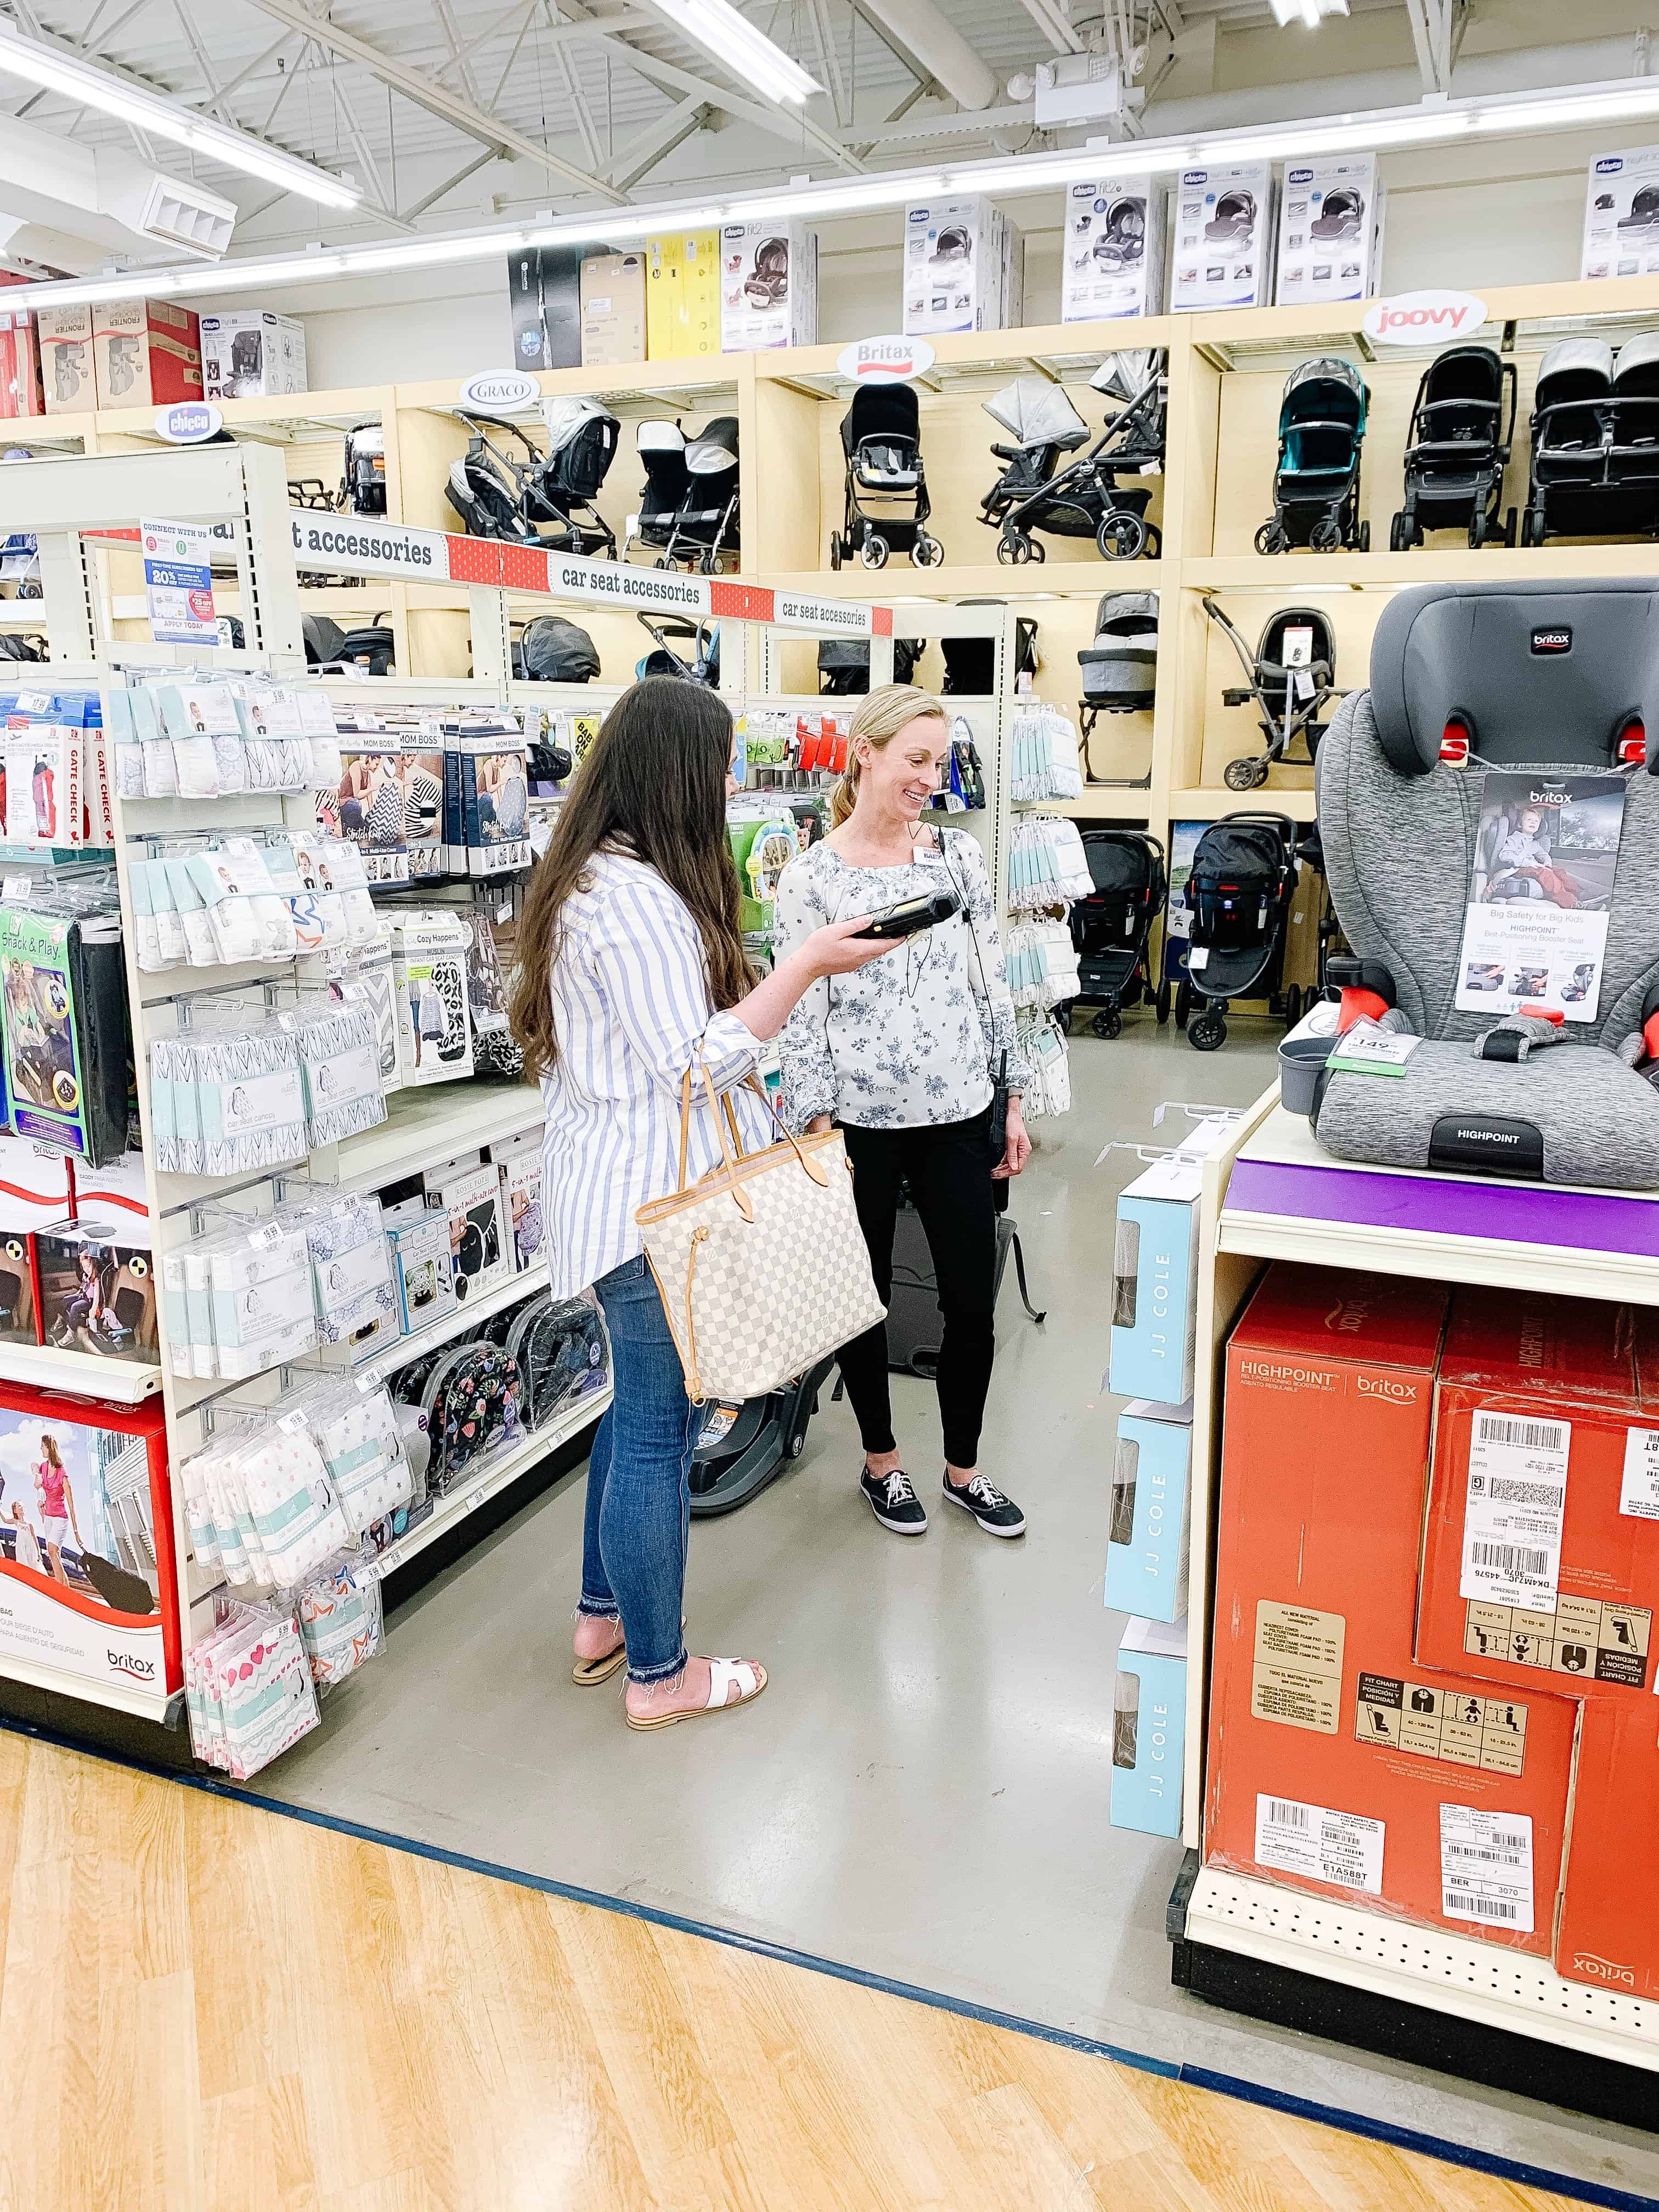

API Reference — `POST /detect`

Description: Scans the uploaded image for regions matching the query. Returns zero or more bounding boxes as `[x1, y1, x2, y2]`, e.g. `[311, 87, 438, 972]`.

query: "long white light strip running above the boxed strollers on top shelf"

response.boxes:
[29, 77, 1659, 307]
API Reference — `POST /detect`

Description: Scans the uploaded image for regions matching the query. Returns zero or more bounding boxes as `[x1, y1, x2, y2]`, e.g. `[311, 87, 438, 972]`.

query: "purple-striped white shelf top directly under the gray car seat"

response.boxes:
[1217, 1106, 1659, 1305]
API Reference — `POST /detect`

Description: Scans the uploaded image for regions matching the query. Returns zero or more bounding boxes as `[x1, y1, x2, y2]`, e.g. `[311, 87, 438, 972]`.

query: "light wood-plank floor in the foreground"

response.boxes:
[0, 1734, 1601, 2212]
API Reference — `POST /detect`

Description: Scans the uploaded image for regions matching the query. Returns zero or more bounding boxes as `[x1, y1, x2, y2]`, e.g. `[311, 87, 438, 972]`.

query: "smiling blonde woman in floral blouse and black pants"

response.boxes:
[776, 684, 1031, 1537]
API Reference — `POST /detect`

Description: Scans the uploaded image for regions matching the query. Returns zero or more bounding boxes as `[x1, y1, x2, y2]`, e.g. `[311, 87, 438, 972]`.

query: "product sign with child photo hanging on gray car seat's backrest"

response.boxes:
[1455, 770, 1626, 1022]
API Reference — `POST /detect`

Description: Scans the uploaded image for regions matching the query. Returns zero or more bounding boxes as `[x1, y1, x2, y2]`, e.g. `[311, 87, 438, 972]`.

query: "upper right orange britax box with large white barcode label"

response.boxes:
[1415, 1290, 1659, 1699]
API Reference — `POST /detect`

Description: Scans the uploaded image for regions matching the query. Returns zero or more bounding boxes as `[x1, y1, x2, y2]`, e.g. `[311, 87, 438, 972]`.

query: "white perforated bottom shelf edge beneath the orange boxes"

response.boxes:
[1186, 1867, 1659, 2070]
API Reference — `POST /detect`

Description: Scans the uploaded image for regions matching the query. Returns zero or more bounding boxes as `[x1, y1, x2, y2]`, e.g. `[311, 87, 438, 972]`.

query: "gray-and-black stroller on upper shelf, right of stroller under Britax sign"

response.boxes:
[980, 354, 1168, 564]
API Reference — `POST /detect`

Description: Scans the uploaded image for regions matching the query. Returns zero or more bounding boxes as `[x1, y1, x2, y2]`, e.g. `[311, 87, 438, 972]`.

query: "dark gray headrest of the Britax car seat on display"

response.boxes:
[1372, 577, 1659, 776]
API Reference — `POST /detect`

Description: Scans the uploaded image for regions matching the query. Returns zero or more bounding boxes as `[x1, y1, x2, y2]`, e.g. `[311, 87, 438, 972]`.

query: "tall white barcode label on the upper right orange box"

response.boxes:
[1458, 1409, 1573, 1612]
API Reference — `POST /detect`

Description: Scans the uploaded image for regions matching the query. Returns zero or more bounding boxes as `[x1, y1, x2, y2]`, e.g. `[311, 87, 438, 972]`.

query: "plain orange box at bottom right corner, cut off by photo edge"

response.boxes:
[1555, 1697, 1659, 1997]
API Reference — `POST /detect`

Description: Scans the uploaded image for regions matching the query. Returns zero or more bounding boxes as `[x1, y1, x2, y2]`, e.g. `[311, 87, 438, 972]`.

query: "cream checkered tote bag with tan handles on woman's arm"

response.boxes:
[635, 1066, 885, 1402]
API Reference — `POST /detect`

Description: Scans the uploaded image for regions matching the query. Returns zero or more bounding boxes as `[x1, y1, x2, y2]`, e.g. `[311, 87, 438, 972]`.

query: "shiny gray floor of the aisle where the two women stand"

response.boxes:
[257, 1018, 1659, 2194]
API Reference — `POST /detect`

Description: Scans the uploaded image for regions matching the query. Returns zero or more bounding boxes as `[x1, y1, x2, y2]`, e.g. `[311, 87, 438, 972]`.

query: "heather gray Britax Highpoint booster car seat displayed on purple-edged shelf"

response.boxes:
[1314, 579, 1659, 1190]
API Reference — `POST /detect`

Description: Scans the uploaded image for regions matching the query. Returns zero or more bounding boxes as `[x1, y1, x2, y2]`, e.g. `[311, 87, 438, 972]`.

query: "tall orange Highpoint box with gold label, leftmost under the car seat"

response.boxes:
[1203, 1265, 1577, 1957]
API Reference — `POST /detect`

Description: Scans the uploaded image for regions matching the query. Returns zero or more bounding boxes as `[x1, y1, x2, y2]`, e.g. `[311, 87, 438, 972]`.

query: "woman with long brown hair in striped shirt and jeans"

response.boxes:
[513, 677, 894, 1728]
